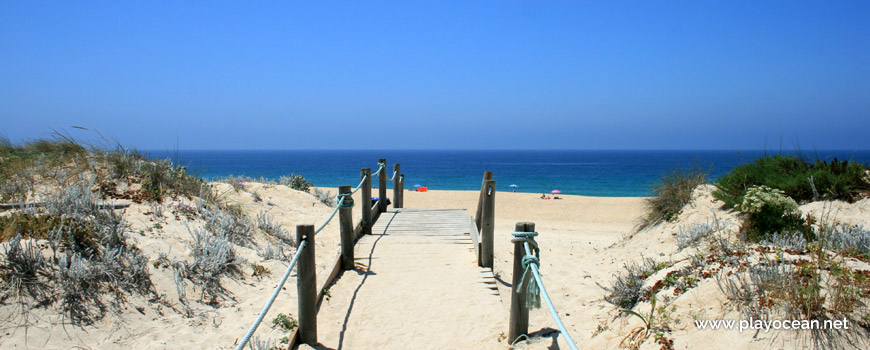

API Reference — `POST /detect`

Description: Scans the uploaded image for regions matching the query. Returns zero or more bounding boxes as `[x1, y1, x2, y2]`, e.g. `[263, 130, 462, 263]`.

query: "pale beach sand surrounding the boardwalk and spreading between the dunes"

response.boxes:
[0, 183, 868, 349]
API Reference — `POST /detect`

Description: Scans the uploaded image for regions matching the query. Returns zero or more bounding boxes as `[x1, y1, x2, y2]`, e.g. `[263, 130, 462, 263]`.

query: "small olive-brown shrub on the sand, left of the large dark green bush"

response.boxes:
[639, 164, 707, 229]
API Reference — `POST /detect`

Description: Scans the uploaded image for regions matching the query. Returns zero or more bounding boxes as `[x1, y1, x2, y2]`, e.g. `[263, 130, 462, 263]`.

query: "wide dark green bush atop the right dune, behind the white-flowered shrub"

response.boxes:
[713, 155, 870, 207]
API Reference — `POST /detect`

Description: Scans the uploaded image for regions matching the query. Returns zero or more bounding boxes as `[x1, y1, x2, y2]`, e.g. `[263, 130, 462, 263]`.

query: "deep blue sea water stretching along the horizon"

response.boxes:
[147, 150, 870, 197]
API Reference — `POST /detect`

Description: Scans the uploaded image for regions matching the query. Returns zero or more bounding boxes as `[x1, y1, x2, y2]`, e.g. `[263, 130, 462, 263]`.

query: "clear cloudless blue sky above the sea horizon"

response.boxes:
[0, 1, 870, 150]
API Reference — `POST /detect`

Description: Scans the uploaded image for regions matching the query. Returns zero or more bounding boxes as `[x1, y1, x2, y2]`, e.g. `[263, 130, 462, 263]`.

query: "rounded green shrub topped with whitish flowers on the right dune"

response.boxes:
[734, 186, 814, 241]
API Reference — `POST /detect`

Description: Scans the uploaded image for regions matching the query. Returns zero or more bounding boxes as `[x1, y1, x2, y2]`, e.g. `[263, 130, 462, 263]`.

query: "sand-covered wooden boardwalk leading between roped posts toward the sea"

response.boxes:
[317, 209, 509, 349]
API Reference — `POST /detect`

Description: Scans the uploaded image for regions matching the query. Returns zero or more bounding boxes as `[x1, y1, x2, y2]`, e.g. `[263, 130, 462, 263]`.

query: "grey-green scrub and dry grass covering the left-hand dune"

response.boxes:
[0, 134, 326, 326]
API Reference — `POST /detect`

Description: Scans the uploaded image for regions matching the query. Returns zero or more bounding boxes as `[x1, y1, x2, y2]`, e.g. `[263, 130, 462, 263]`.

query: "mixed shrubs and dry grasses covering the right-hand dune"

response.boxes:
[620, 155, 870, 348]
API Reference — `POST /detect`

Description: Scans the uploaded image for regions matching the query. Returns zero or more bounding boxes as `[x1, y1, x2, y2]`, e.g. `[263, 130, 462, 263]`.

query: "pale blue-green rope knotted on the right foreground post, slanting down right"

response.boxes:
[511, 231, 578, 350]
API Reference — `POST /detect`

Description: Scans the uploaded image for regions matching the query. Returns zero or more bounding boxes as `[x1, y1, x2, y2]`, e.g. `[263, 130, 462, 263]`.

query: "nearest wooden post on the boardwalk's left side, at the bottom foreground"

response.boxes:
[296, 225, 317, 346]
